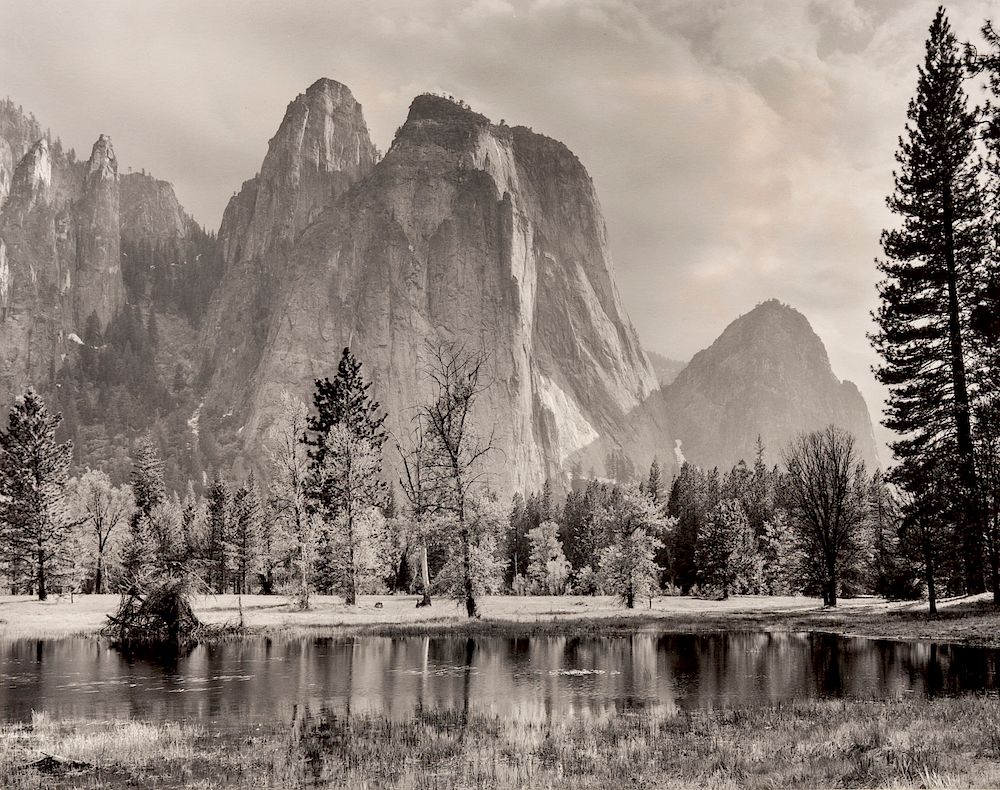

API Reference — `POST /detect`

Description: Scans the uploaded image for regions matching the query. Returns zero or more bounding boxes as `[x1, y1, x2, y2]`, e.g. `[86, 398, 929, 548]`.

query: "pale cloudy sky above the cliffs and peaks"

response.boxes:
[0, 0, 1000, 460]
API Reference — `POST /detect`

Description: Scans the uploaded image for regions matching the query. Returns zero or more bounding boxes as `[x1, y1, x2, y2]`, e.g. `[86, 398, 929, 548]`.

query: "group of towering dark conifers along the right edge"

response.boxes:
[871, 8, 1000, 611]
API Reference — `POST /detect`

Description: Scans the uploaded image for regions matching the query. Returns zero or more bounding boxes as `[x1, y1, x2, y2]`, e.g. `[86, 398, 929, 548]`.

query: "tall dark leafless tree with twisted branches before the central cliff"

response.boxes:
[421, 342, 494, 617]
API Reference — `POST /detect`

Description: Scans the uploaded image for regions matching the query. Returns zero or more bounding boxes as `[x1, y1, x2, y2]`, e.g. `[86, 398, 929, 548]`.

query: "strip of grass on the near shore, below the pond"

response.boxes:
[0, 697, 1000, 790]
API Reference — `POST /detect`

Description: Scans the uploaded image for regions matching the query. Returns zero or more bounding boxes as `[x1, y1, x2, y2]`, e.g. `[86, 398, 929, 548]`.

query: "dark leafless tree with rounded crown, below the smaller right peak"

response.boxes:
[782, 425, 868, 606]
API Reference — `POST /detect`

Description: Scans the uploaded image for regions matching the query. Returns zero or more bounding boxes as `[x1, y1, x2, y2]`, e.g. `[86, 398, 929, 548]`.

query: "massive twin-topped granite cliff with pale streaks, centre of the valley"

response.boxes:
[206, 86, 673, 490]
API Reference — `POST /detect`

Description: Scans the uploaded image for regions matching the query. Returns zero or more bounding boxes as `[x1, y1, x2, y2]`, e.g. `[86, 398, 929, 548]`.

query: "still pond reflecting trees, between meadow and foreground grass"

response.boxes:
[0, 633, 1000, 728]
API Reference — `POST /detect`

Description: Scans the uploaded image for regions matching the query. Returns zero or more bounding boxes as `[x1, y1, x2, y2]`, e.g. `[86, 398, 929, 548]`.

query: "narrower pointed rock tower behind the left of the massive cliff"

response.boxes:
[203, 79, 376, 420]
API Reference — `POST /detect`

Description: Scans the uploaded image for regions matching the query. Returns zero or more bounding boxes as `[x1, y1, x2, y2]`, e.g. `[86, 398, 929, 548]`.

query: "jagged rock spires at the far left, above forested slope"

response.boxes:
[0, 113, 138, 402]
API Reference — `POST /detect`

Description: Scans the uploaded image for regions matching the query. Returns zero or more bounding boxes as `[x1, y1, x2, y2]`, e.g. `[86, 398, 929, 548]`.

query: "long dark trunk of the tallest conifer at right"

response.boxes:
[942, 184, 985, 595]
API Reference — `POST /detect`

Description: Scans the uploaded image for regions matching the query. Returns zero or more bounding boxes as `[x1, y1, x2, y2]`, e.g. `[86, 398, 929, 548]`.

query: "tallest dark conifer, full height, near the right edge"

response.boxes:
[872, 8, 985, 593]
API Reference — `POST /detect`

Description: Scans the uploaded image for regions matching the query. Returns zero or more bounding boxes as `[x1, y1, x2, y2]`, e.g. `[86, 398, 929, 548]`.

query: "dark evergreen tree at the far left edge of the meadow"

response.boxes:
[0, 387, 73, 601]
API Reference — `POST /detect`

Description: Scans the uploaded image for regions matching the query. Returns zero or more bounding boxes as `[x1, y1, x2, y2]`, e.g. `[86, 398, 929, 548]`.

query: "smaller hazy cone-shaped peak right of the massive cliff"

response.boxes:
[664, 300, 879, 469]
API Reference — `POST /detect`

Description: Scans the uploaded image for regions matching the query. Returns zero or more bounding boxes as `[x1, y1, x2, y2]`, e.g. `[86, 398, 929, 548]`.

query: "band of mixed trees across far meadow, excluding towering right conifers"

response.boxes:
[0, 346, 920, 616]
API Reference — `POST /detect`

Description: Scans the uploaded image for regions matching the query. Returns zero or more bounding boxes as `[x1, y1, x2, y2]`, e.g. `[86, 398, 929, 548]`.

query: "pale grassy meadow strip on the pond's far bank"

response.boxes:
[0, 595, 1000, 646]
